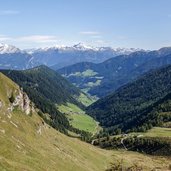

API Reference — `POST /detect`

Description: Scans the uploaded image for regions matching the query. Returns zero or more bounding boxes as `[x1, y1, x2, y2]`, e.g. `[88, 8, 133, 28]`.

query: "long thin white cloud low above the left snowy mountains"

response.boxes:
[16, 35, 58, 43]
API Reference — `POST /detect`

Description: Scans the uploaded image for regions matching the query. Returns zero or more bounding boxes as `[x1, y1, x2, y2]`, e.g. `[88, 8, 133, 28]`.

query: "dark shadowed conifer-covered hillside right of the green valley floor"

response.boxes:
[87, 66, 171, 134]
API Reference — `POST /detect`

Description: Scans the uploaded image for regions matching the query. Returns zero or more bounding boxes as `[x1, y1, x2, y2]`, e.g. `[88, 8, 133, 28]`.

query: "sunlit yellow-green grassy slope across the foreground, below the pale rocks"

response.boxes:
[0, 104, 170, 171]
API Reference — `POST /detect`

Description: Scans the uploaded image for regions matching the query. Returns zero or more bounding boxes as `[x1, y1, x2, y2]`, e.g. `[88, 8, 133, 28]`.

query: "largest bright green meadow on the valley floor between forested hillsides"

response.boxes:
[58, 103, 99, 134]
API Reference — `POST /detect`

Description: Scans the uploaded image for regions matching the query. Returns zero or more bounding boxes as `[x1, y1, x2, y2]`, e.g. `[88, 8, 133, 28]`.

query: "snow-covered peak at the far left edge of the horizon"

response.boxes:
[0, 43, 20, 54]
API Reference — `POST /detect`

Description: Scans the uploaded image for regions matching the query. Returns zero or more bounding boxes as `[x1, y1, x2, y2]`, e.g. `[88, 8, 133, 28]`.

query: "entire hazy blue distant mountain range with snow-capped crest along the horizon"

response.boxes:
[0, 43, 140, 70]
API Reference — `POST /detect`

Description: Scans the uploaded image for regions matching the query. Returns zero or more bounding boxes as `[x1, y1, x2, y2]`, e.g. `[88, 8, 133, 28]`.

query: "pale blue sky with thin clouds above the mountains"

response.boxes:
[0, 0, 171, 49]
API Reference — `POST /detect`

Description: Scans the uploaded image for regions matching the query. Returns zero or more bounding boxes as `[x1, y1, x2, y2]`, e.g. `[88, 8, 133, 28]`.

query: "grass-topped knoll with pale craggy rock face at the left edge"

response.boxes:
[0, 73, 34, 115]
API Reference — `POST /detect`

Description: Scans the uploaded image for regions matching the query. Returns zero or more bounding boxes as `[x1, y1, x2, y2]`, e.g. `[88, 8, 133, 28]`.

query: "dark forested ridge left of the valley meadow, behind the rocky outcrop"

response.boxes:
[1, 66, 91, 132]
